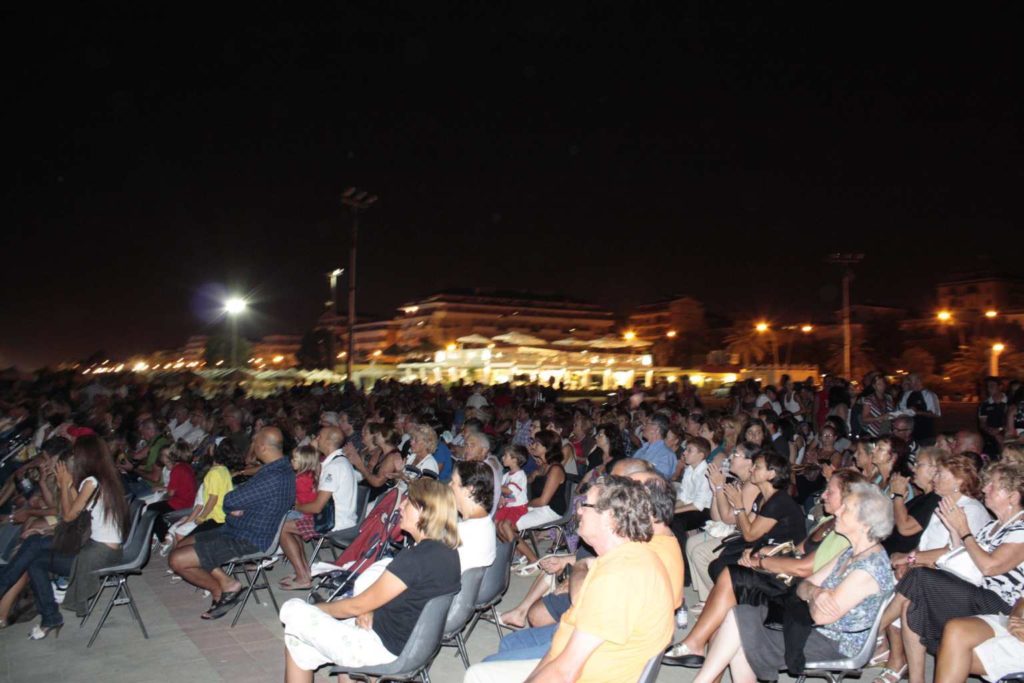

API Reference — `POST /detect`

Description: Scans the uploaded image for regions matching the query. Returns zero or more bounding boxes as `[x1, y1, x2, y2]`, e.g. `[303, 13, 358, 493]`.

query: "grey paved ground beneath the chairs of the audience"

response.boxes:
[0, 557, 931, 683]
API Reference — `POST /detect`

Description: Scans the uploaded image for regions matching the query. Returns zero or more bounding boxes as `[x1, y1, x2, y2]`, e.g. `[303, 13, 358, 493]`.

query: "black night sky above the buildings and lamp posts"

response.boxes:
[0, 2, 1024, 367]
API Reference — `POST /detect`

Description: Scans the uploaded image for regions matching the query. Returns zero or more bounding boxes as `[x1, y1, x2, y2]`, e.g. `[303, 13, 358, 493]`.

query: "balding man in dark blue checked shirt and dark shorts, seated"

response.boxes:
[168, 427, 295, 620]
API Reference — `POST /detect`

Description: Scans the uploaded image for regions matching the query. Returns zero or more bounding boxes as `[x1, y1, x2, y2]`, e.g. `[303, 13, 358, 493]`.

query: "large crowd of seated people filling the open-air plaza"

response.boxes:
[6, 374, 1024, 683]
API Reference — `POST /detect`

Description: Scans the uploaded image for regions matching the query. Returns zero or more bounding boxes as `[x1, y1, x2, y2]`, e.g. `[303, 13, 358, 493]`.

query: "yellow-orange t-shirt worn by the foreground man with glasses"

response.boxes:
[550, 543, 675, 683]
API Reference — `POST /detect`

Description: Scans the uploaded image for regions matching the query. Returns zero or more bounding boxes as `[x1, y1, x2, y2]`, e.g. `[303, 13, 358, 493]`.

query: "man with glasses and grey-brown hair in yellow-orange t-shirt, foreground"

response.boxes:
[465, 476, 676, 683]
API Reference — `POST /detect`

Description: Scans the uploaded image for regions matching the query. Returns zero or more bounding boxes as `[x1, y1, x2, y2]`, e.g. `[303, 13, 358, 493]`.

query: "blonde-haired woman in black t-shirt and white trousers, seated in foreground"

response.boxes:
[281, 478, 460, 683]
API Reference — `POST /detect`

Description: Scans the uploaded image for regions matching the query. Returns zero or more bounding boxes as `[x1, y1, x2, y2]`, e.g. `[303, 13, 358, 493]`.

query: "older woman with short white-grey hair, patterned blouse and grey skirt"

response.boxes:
[694, 483, 896, 683]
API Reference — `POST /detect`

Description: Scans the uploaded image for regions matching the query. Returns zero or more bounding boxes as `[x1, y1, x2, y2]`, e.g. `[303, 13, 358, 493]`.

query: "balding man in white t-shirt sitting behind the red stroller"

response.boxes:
[281, 427, 358, 591]
